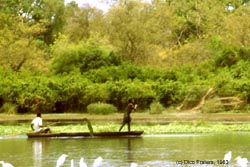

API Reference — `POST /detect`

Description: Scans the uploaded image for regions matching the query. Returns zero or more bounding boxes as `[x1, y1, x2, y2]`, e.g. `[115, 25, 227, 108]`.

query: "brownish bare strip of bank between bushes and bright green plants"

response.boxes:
[0, 112, 250, 124]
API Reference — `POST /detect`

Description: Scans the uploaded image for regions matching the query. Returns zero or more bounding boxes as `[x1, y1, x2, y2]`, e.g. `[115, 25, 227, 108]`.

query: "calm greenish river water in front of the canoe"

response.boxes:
[0, 133, 250, 167]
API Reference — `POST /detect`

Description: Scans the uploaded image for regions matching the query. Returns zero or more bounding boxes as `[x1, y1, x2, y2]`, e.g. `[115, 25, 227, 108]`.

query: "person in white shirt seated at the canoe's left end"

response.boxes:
[30, 113, 51, 133]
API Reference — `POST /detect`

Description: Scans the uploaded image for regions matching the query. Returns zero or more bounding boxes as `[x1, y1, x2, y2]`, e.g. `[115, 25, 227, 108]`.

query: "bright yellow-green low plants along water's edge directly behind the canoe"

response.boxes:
[0, 122, 250, 136]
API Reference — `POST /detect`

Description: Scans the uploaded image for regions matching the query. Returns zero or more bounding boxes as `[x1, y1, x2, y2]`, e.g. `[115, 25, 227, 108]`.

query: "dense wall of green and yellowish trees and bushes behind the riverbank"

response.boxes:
[0, 0, 250, 113]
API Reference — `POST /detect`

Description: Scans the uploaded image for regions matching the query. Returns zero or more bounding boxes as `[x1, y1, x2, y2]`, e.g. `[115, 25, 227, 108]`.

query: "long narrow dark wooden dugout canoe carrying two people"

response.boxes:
[26, 131, 144, 138]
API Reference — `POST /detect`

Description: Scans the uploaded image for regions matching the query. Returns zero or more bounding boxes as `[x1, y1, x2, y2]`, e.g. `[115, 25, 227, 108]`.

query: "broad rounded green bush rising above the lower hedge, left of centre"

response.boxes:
[51, 43, 120, 74]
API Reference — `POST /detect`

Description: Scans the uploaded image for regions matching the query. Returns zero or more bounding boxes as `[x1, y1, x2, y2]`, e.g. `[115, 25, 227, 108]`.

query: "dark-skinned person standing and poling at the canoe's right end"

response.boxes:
[119, 99, 137, 132]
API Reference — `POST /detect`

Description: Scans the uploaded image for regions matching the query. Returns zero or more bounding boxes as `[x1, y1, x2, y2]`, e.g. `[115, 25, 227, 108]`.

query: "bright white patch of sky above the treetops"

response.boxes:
[64, 0, 112, 12]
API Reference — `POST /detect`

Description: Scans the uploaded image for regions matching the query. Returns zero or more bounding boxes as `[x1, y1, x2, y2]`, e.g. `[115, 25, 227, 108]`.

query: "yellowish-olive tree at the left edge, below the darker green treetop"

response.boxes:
[0, 13, 46, 71]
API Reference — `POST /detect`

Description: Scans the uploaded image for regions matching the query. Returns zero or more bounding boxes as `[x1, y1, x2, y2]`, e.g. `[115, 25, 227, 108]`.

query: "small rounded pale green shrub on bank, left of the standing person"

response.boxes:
[87, 102, 117, 115]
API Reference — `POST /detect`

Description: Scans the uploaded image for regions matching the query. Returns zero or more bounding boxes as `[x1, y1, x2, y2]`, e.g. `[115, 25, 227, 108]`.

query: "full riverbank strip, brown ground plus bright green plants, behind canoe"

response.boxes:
[0, 113, 250, 136]
